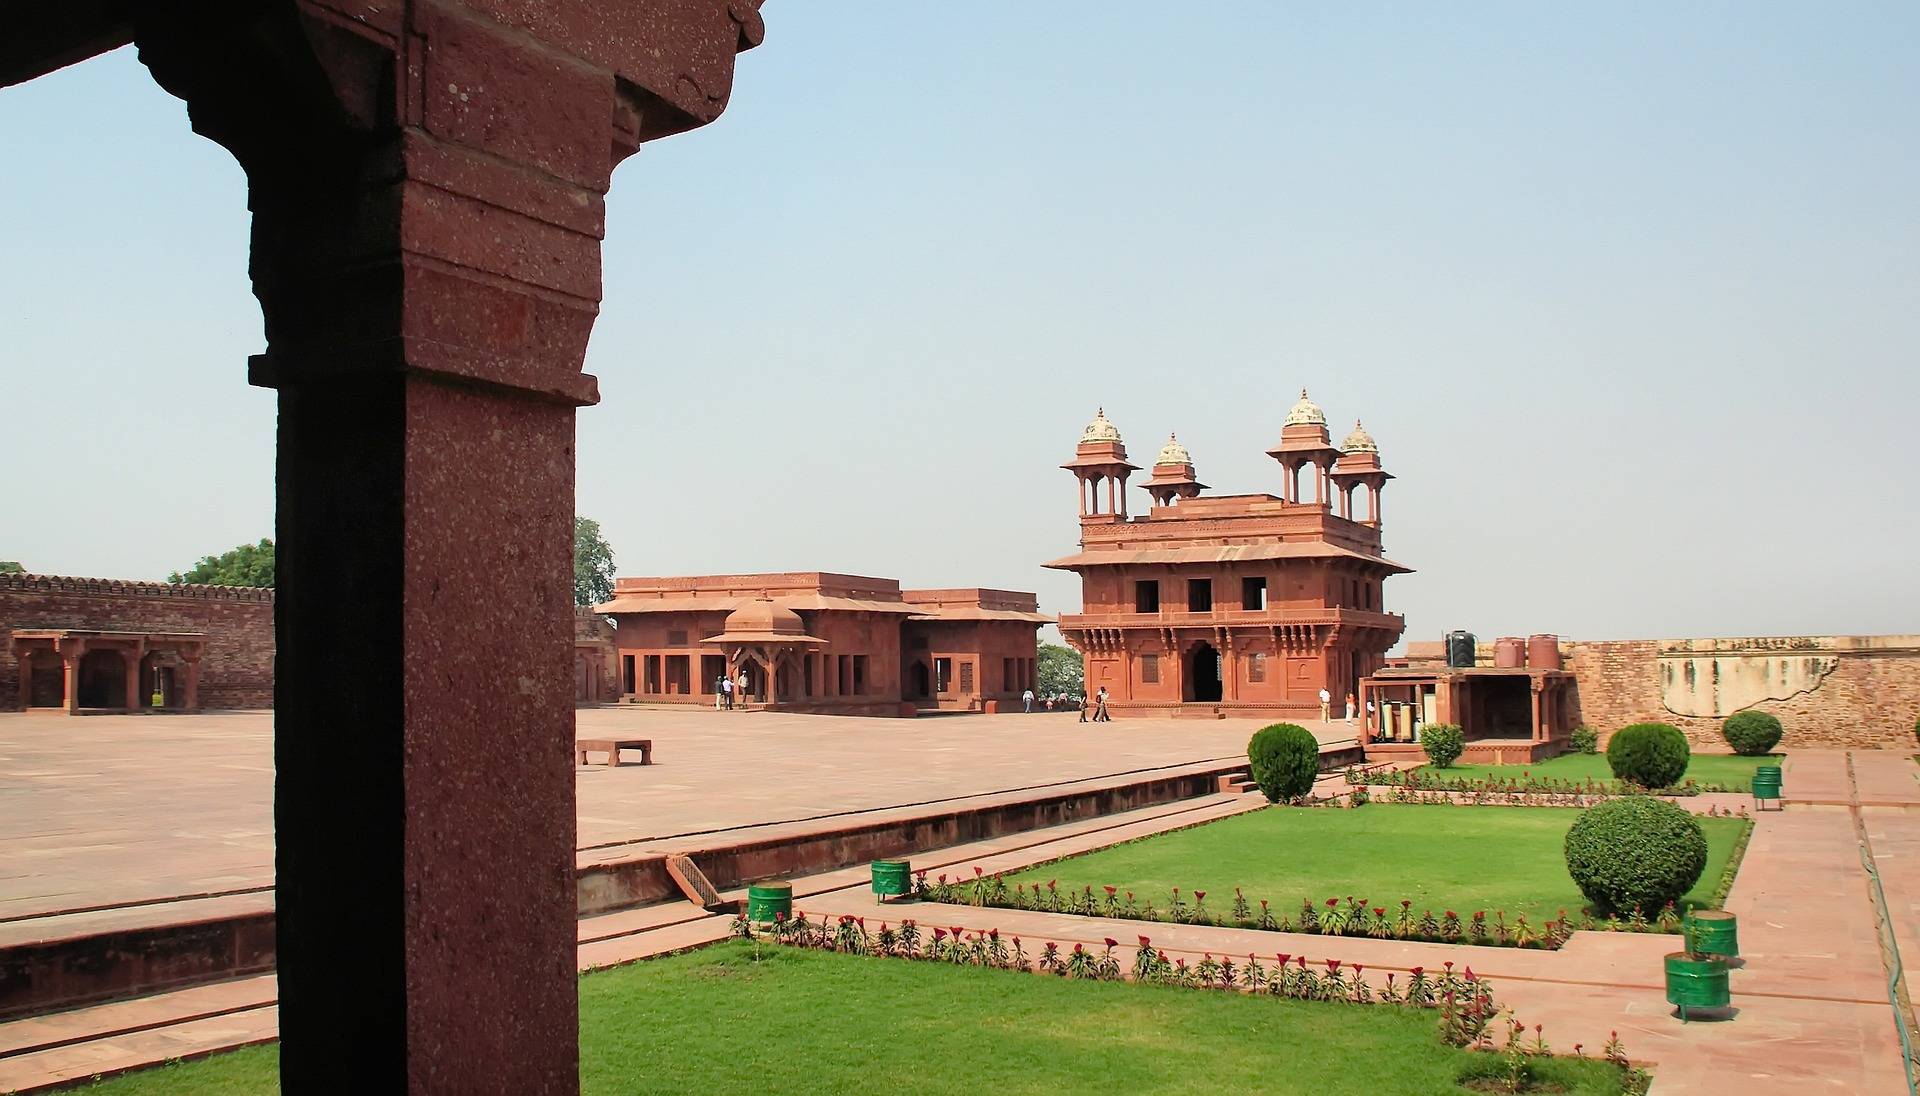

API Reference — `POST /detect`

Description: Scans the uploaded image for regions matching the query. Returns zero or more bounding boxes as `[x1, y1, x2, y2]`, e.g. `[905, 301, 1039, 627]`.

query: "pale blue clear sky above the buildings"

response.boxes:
[0, 0, 1920, 639]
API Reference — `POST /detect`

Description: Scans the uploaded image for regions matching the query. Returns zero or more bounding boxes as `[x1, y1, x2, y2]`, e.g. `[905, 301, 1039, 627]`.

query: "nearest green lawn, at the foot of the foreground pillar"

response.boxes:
[86, 942, 1619, 1096]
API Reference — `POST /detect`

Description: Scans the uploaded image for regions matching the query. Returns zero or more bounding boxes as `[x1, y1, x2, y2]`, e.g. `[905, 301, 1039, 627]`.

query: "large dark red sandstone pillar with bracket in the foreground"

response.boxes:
[0, 0, 762, 1092]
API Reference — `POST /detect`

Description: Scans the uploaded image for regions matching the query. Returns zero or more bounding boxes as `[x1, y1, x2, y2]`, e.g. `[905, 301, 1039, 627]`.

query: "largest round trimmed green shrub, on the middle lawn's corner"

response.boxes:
[1567, 798, 1707, 917]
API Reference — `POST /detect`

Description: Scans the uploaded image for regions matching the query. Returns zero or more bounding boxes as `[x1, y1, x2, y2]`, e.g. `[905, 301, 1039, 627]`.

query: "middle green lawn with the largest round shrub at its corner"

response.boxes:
[1008, 802, 1745, 927]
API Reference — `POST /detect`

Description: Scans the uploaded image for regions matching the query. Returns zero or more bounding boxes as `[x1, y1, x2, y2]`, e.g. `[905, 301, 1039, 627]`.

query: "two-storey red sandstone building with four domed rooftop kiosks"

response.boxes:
[1046, 392, 1409, 718]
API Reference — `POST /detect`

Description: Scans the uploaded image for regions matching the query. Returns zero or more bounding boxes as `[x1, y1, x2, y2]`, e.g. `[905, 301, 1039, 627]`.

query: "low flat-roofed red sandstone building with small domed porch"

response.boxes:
[595, 572, 1052, 716]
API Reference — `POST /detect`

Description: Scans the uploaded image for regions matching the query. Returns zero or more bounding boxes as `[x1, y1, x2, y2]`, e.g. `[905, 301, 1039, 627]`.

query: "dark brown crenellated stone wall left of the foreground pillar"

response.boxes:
[0, 574, 273, 710]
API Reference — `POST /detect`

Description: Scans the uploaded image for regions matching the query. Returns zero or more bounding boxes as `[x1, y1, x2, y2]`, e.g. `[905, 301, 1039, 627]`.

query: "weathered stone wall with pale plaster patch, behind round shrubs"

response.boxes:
[1561, 635, 1920, 751]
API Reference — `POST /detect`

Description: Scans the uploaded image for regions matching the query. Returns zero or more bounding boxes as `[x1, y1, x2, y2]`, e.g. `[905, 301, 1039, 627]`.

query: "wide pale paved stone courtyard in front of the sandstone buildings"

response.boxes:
[0, 708, 1352, 921]
